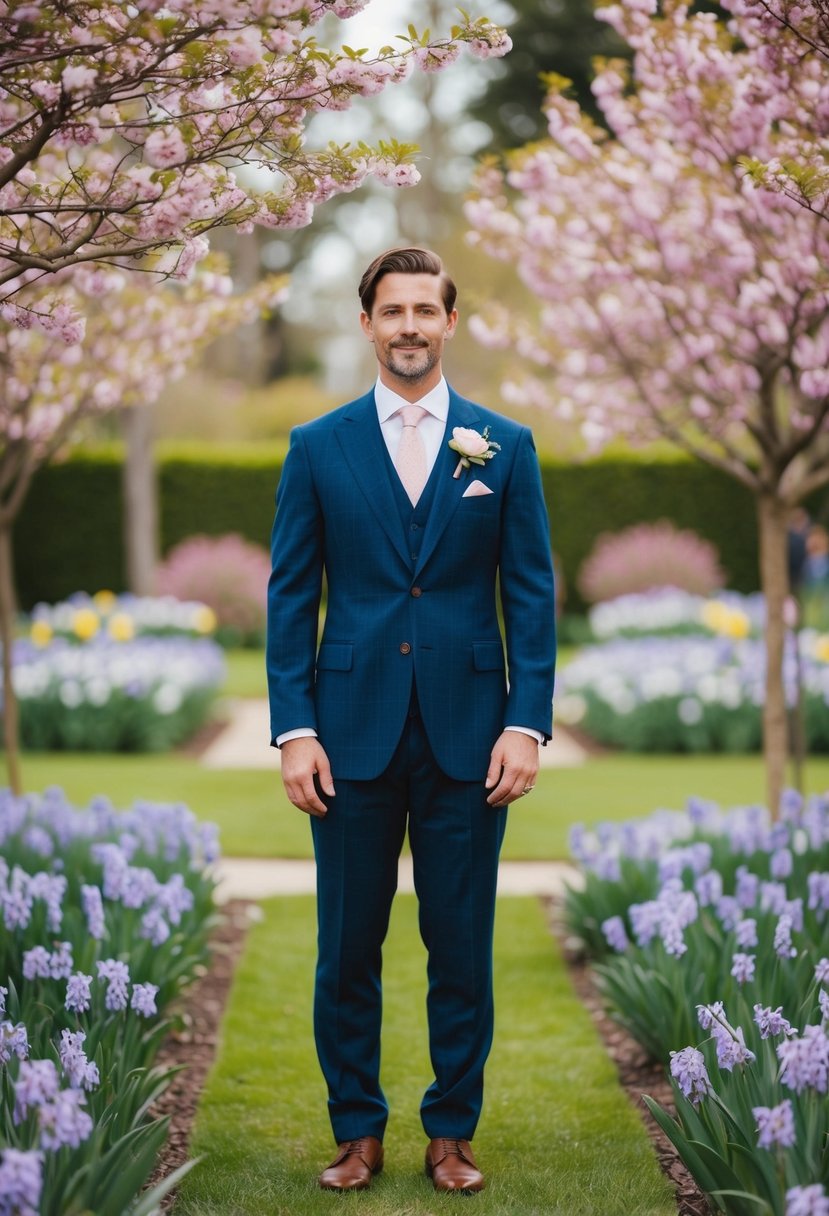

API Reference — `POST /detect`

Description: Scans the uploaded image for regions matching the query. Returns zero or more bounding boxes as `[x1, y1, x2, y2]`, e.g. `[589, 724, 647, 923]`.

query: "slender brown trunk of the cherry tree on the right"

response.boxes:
[757, 494, 789, 818]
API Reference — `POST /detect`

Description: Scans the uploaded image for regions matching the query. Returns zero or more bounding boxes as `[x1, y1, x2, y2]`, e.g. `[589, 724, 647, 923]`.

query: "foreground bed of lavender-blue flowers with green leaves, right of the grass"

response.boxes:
[566, 794, 829, 1216]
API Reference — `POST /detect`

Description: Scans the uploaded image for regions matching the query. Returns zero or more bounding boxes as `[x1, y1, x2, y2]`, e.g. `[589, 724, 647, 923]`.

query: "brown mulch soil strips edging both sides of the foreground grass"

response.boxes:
[145, 899, 711, 1216]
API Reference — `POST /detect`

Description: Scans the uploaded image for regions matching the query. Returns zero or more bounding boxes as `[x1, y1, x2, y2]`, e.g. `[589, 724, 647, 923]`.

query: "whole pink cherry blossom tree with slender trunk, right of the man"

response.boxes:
[467, 0, 829, 807]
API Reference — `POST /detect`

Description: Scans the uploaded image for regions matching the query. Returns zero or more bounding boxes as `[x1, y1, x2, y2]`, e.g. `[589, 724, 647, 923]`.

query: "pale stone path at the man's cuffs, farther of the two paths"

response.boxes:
[201, 698, 586, 770]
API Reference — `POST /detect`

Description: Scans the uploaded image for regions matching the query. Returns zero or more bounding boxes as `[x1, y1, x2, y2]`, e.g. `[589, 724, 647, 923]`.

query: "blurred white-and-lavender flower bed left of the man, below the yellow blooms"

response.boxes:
[12, 634, 225, 751]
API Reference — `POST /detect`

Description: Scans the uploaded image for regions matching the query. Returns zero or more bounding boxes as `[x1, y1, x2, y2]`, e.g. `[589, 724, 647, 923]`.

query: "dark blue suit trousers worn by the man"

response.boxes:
[311, 697, 507, 1143]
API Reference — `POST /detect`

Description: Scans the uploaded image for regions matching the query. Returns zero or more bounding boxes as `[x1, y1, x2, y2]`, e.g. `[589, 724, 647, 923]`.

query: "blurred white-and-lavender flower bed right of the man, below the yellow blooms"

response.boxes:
[557, 630, 829, 751]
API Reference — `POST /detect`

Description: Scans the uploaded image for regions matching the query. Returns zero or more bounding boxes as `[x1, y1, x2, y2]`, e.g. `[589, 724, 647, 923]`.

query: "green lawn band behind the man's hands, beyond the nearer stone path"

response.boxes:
[14, 753, 829, 858]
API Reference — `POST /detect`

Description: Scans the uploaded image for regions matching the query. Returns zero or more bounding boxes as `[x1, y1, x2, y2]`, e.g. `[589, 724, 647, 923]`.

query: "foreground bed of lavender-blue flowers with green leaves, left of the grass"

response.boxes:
[0, 789, 218, 1216]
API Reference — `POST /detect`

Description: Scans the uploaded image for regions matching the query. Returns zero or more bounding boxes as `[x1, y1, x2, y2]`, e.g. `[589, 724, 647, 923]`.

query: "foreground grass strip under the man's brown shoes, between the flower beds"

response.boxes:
[175, 896, 676, 1216]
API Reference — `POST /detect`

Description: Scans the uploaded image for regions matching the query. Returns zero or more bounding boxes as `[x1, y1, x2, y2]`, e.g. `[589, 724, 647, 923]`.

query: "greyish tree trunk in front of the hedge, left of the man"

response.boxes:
[122, 405, 158, 596]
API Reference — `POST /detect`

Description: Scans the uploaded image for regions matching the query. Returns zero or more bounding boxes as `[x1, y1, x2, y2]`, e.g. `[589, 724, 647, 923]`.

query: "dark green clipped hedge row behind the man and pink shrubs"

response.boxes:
[15, 447, 757, 612]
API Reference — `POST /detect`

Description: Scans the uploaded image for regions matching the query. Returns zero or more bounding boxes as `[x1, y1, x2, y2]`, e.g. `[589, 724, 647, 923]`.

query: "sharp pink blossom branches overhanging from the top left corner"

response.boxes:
[0, 0, 511, 342]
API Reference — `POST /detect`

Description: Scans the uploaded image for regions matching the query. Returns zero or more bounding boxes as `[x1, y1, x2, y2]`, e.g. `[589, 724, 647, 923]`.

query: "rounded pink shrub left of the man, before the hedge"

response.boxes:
[157, 534, 271, 641]
